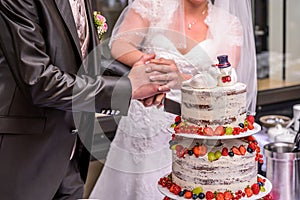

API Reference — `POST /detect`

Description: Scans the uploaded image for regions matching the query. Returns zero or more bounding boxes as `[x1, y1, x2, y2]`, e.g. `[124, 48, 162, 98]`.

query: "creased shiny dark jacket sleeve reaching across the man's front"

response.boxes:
[0, 0, 131, 115]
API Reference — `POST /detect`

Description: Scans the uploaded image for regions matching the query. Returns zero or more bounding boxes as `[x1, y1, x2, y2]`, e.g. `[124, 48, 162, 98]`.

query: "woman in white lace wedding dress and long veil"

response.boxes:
[90, 0, 256, 200]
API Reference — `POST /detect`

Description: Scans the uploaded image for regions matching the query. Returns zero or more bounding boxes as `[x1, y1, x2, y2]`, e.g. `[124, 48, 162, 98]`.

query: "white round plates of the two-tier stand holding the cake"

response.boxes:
[158, 123, 272, 200]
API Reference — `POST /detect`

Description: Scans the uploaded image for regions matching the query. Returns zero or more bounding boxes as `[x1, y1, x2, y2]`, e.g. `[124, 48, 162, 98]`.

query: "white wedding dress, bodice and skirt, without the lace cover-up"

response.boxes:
[90, 0, 238, 200]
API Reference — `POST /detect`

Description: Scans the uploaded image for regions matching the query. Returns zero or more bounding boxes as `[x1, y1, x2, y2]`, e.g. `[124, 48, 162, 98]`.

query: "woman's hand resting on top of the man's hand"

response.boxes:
[148, 58, 187, 90]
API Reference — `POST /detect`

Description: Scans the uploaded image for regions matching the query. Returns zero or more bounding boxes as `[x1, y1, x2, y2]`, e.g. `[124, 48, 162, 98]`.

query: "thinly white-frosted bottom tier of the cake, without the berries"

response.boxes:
[172, 139, 257, 192]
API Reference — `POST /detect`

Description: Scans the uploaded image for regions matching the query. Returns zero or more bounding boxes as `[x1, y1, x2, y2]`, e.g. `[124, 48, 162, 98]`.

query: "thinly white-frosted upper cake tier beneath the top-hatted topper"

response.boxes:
[181, 83, 246, 128]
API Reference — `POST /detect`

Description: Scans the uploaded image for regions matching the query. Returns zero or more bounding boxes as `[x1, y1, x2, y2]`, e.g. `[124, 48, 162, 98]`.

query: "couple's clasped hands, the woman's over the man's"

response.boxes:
[128, 54, 186, 107]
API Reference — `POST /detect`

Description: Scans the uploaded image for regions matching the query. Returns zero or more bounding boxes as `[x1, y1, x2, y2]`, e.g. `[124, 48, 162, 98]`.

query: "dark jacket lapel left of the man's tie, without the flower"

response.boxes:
[55, 0, 82, 59]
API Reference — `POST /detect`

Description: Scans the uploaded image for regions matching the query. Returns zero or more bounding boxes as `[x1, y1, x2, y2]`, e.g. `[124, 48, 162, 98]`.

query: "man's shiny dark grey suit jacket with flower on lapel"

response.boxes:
[0, 0, 131, 200]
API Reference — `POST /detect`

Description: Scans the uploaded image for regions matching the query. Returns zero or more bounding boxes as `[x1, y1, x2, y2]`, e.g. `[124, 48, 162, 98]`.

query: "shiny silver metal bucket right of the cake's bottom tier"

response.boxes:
[264, 142, 300, 200]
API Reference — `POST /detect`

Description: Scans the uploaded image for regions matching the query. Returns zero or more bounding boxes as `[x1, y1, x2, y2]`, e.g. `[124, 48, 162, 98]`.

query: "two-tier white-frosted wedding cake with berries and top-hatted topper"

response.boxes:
[159, 55, 266, 200]
